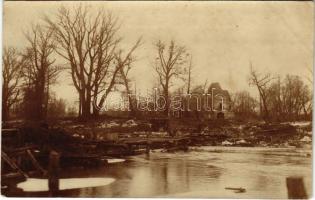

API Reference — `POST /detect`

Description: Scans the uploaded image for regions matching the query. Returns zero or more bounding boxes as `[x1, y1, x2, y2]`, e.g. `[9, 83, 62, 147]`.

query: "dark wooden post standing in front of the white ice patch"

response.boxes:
[48, 151, 60, 195]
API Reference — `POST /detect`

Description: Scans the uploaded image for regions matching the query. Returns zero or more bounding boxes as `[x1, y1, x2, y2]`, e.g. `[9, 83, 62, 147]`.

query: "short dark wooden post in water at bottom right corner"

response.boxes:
[286, 177, 307, 199]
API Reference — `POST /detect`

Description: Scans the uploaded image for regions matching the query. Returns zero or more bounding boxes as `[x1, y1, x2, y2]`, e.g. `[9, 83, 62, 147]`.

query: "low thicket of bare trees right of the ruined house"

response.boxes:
[237, 67, 312, 121]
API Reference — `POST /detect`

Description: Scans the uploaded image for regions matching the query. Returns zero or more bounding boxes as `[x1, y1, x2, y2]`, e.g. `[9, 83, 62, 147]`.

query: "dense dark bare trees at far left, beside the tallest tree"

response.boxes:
[2, 25, 60, 120]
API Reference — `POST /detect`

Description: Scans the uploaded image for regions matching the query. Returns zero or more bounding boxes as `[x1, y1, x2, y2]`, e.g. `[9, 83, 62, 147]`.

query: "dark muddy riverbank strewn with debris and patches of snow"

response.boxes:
[3, 119, 312, 160]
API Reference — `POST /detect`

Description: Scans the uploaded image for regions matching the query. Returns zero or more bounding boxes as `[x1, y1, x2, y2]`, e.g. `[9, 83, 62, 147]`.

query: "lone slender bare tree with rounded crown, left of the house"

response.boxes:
[154, 40, 187, 116]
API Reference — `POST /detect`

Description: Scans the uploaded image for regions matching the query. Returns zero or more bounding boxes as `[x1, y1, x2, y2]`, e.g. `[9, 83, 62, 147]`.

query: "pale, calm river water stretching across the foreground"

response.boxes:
[15, 147, 312, 199]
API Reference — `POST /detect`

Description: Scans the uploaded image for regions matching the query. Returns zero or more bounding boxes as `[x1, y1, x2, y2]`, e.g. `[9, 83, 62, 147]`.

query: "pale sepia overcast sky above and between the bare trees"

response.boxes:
[3, 1, 314, 103]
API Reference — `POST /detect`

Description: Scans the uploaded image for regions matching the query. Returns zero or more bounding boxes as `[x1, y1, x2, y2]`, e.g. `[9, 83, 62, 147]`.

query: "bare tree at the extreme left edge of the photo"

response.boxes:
[2, 47, 24, 121]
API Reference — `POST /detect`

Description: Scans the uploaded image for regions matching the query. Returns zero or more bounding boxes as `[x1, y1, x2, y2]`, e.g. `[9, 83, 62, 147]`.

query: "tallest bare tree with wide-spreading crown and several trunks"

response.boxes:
[45, 6, 138, 118]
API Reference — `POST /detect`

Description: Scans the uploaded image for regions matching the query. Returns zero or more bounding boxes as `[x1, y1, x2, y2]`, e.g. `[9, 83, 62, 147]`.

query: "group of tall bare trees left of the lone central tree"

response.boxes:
[2, 6, 141, 120]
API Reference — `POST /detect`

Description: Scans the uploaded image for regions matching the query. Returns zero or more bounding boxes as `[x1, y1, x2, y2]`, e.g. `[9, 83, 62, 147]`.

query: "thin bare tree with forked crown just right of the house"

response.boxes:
[249, 66, 273, 121]
